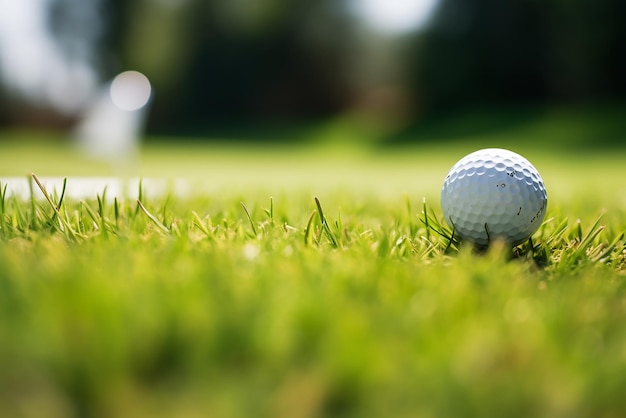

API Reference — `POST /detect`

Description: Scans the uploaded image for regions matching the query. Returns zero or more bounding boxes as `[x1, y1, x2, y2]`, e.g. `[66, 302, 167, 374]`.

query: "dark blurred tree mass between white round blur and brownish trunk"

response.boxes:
[107, 0, 355, 131]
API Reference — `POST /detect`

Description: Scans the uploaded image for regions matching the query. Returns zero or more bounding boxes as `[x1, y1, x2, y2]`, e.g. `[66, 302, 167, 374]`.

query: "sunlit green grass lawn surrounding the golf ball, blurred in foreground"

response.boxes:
[0, 129, 626, 417]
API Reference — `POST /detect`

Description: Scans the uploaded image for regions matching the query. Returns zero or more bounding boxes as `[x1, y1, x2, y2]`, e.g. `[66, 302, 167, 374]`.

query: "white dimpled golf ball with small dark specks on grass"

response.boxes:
[441, 148, 548, 246]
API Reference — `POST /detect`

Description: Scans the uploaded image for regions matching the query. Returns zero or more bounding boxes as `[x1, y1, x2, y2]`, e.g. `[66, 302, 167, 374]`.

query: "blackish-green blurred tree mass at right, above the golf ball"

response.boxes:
[411, 0, 626, 109]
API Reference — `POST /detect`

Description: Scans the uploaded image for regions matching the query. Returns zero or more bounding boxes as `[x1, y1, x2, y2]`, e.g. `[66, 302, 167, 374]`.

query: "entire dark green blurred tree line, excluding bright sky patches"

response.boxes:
[0, 0, 626, 132]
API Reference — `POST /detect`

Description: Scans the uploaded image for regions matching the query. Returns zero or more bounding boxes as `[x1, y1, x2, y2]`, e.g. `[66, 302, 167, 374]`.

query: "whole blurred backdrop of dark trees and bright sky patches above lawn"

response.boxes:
[0, 0, 626, 150]
